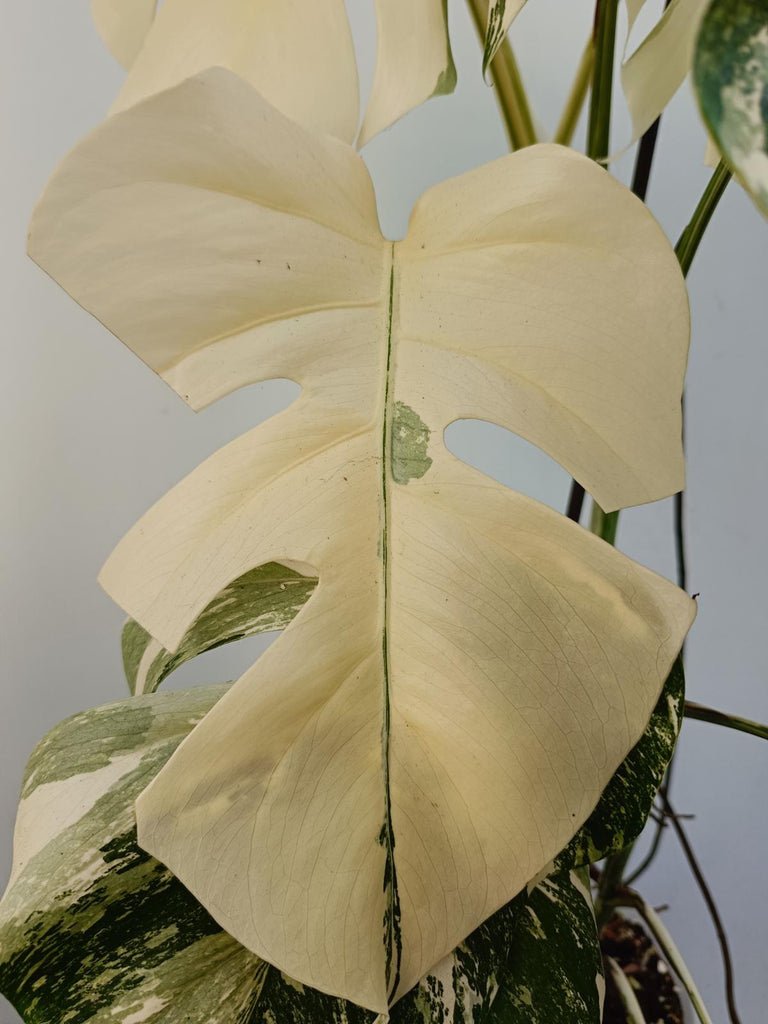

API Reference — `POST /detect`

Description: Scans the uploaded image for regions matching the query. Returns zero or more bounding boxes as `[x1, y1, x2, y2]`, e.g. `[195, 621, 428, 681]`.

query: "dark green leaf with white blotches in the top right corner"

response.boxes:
[693, 0, 768, 215]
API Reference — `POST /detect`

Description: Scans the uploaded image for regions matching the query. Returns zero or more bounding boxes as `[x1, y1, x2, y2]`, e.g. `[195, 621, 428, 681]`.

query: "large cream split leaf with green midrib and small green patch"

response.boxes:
[31, 71, 693, 1012]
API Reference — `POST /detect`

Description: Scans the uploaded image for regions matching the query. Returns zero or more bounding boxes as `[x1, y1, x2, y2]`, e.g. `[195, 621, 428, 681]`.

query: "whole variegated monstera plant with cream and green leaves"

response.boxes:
[0, 0, 768, 1024]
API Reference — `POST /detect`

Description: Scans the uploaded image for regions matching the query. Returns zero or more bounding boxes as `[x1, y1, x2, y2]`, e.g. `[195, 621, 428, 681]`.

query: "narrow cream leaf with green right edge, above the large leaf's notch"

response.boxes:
[358, 0, 456, 146]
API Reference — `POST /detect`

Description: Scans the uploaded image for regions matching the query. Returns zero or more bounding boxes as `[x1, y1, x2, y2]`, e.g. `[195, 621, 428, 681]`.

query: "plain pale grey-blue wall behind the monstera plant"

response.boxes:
[0, 0, 768, 1024]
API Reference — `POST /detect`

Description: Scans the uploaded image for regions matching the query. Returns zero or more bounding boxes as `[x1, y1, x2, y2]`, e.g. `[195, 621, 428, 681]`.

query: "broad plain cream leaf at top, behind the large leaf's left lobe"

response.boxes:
[113, 0, 359, 142]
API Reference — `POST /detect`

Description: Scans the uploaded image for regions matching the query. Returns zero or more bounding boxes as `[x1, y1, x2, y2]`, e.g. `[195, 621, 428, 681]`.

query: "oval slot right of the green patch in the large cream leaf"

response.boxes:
[443, 420, 570, 512]
